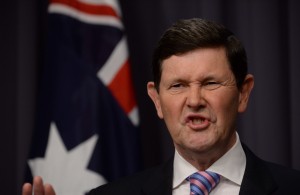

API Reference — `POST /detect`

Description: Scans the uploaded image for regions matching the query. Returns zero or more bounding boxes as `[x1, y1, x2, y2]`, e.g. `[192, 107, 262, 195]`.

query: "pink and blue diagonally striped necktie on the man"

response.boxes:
[187, 171, 220, 195]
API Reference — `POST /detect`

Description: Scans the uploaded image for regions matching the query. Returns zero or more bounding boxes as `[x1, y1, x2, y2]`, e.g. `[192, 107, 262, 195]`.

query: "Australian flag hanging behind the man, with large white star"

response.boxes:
[24, 0, 141, 195]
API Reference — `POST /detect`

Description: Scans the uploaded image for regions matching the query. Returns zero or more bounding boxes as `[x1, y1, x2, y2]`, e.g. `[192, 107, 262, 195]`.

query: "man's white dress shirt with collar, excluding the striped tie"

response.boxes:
[173, 133, 246, 195]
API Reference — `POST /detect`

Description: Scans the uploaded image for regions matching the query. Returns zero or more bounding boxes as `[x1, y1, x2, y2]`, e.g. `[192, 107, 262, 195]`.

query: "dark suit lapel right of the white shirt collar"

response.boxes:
[239, 145, 277, 195]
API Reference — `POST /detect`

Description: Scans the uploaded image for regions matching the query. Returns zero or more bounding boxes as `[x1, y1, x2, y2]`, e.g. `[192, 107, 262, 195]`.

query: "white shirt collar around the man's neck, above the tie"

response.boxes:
[173, 133, 246, 188]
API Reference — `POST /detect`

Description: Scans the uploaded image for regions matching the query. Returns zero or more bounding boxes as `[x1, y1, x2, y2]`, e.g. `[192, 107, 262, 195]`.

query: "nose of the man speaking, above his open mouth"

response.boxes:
[186, 85, 205, 109]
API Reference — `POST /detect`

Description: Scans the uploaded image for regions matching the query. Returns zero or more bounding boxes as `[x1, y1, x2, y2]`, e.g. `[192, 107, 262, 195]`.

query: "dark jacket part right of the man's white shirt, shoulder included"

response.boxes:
[240, 142, 300, 195]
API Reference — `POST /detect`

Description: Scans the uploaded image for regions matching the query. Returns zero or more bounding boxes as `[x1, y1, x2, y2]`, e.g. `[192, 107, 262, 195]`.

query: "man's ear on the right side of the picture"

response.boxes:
[238, 74, 254, 112]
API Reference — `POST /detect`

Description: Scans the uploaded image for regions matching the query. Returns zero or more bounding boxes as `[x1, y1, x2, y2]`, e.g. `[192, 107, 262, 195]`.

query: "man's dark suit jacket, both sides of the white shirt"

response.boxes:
[89, 145, 300, 195]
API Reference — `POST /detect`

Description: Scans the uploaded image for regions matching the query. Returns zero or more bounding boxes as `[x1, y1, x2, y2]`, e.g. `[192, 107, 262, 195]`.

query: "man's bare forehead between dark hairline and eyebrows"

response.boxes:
[162, 47, 231, 77]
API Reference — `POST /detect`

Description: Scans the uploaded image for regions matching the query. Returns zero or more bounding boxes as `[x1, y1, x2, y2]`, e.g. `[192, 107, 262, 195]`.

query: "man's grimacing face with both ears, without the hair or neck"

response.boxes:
[148, 48, 253, 160]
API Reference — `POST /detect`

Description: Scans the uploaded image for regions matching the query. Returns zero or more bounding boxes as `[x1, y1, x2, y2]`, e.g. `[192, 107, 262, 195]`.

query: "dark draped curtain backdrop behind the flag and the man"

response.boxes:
[0, 0, 300, 194]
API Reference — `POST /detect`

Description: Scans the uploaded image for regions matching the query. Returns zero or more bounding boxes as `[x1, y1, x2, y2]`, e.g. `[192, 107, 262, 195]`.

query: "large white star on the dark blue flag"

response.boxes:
[28, 123, 106, 195]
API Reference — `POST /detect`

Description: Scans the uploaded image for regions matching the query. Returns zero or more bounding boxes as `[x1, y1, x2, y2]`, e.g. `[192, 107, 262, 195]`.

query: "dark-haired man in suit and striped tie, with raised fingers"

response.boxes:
[23, 19, 300, 195]
